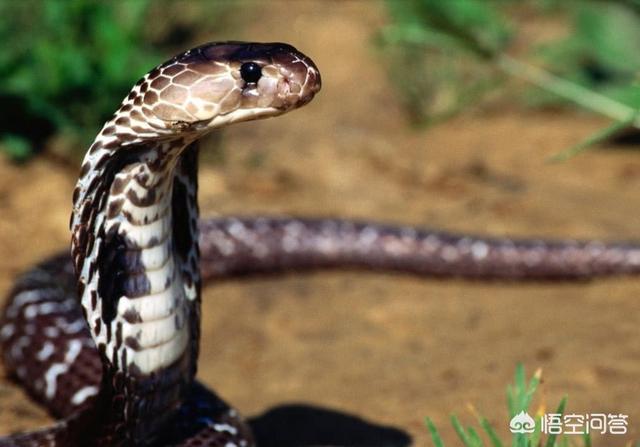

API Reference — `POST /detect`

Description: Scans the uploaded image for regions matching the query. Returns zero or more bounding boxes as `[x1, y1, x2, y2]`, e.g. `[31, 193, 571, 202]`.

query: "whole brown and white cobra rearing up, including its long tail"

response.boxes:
[0, 41, 640, 447]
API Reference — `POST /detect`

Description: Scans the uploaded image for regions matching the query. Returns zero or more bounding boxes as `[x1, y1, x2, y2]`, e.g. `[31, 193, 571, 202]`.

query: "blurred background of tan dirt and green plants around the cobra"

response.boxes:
[0, 0, 640, 447]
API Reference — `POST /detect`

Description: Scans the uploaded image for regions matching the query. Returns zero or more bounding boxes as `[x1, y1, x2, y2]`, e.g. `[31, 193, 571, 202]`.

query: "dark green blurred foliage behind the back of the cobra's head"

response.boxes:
[0, 0, 230, 160]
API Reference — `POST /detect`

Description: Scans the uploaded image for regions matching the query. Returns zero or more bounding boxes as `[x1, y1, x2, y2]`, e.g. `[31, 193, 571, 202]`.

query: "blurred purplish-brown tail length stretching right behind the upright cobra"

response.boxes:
[200, 217, 640, 280]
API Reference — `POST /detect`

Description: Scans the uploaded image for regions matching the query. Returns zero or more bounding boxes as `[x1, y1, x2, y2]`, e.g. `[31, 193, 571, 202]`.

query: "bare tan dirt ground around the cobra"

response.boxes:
[0, 1, 640, 446]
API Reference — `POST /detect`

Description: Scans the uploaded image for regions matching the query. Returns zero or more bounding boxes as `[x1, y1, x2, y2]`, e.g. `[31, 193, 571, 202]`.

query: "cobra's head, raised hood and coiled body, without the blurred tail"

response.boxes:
[0, 42, 320, 447]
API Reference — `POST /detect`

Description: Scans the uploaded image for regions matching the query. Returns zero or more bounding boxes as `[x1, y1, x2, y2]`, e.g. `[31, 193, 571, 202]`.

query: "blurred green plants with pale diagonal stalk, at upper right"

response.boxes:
[379, 0, 640, 159]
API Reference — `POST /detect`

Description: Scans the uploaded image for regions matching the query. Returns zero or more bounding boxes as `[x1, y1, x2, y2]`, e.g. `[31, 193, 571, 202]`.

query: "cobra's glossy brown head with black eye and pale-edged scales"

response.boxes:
[129, 42, 321, 133]
